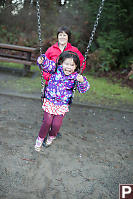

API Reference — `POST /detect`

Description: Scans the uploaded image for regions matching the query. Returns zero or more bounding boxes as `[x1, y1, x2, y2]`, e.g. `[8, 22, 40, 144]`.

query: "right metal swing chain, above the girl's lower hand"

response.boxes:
[80, 0, 105, 73]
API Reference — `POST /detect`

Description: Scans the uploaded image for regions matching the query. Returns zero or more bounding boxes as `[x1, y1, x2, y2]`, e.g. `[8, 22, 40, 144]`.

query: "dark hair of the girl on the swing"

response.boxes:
[57, 51, 80, 72]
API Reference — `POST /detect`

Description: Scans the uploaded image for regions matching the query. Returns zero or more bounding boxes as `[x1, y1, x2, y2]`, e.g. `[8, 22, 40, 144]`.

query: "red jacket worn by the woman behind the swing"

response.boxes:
[43, 42, 86, 84]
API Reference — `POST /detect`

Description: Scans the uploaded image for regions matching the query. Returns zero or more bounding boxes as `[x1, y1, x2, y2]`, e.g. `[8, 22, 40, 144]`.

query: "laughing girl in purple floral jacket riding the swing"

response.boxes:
[35, 51, 90, 151]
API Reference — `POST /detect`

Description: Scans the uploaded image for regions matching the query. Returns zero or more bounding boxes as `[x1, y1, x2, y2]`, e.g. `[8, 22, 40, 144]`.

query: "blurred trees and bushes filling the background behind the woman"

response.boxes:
[0, 0, 133, 72]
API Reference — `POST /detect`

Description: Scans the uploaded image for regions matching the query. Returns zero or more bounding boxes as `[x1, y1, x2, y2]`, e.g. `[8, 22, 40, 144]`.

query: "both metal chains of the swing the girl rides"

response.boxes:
[36, 0, 105, 103]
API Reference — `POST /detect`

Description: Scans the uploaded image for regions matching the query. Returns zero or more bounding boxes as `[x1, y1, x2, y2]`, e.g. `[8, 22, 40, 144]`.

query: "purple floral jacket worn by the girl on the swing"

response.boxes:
[37, 54, 90, 105]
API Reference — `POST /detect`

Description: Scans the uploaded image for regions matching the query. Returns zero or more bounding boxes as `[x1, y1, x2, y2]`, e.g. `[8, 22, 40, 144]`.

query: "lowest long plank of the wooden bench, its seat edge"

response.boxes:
[0, 57, 32, 65]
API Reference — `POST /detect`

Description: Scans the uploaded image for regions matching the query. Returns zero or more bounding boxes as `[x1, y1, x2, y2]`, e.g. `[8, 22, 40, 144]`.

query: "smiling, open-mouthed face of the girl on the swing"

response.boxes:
[62, 58, 77, 75]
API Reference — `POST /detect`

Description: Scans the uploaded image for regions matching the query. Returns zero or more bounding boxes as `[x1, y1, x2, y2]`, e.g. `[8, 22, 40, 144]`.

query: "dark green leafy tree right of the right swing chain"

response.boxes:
[97, 0, 133, 70]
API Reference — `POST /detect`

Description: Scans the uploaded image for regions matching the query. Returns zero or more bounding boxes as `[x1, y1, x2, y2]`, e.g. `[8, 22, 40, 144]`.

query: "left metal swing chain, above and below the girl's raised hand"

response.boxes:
[36, 0, 44, 98]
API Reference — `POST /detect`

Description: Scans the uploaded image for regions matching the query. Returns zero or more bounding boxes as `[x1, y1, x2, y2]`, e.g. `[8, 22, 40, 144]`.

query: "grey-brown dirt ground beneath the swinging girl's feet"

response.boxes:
[0, 72, 133, 199]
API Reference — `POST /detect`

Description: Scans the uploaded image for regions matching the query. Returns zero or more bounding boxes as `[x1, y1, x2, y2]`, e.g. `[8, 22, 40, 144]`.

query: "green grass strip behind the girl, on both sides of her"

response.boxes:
[1, 63, 133, 105]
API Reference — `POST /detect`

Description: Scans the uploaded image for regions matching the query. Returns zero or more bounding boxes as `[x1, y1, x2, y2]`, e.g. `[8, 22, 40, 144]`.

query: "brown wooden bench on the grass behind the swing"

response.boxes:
[0, 43, 37, 74]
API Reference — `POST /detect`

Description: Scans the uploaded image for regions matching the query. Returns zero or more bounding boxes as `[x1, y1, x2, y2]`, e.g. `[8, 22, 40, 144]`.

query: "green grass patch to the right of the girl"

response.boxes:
[77, 75, 133, 105]
